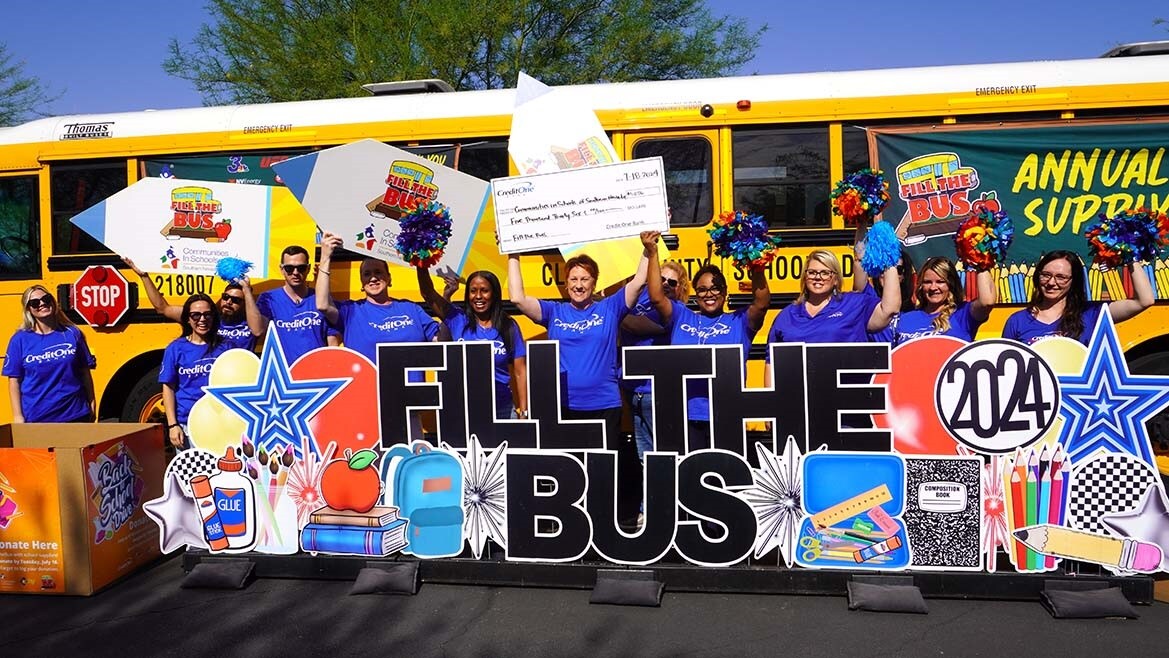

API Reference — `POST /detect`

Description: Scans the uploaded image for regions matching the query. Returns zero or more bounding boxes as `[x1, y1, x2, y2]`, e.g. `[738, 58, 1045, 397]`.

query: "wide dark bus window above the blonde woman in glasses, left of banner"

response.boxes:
[731, 126, 831, 228]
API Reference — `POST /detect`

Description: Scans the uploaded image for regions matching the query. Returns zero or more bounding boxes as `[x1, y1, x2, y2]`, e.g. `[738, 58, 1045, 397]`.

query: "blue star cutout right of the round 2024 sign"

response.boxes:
[1059, 311, 1169, 465]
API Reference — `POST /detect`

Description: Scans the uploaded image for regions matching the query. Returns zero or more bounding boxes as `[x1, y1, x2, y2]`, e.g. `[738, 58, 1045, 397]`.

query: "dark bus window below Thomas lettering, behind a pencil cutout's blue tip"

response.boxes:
[49, 161, 126, 256]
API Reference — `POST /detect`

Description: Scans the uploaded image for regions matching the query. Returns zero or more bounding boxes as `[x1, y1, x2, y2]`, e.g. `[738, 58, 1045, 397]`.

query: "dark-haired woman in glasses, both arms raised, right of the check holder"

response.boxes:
[645, 247, 772, 450]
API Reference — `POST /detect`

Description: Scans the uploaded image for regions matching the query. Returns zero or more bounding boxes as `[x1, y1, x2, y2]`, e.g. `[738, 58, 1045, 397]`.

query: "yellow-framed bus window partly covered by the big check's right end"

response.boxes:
[632, 137, 714, 227]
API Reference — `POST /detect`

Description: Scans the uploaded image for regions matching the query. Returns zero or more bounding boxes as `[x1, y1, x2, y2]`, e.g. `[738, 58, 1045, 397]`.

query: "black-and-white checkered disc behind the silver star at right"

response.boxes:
[1067, 452, 1157, 534]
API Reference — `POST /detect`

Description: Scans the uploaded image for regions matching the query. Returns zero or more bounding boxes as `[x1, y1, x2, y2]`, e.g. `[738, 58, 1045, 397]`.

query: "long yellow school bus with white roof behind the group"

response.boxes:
[0, 46, 1169, 448]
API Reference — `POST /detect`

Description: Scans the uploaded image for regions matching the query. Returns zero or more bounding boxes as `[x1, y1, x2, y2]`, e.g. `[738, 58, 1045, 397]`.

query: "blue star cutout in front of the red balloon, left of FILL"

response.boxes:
[205, 331, 352, 457]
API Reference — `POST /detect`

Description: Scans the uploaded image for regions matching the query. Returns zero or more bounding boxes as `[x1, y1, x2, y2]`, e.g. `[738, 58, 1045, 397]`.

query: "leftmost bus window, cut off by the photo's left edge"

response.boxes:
[0, 176, 41, 279]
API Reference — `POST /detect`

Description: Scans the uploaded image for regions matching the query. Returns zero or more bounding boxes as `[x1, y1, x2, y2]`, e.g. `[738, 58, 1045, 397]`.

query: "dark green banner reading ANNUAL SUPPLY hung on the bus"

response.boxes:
[874, 123, 1169, 303]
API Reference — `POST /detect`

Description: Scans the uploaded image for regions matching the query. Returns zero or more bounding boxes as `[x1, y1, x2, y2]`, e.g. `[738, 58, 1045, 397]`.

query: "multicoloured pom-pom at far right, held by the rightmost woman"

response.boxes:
[1084, 208, 1169, 269]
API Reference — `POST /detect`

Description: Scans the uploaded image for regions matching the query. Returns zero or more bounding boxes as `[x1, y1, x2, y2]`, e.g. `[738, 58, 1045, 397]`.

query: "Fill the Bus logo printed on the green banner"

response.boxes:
[897, 152, 1001, 244]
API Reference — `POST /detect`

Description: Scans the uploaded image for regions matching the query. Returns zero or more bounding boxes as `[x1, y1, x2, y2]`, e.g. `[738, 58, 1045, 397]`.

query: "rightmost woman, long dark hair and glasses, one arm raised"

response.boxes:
[1003, 250, 1156, 345]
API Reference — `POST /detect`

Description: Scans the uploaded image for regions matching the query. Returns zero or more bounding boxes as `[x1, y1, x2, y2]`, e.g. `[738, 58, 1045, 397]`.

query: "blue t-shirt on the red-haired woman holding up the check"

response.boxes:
[540, 288, 629, 411]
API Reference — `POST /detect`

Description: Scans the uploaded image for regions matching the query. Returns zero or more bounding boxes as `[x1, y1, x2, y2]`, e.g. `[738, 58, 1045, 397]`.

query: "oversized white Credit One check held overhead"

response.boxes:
[491, 158, 670, 254]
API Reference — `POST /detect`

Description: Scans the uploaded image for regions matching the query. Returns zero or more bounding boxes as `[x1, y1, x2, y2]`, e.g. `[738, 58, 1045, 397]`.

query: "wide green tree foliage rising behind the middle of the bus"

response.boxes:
[162, 0, 767, 104]
